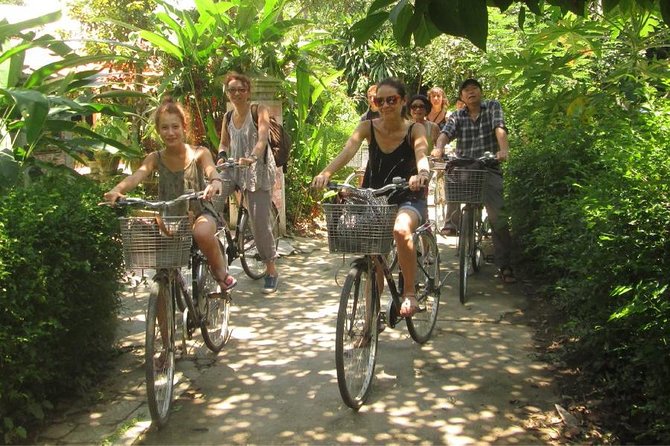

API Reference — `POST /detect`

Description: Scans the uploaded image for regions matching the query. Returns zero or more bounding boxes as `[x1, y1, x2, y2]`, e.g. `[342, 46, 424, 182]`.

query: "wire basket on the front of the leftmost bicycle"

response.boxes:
[119, 216, 191, 268]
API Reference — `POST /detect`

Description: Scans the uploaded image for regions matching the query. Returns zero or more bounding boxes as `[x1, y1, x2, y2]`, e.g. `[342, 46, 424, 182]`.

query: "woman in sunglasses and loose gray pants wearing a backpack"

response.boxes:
[219, 73, 279, 294]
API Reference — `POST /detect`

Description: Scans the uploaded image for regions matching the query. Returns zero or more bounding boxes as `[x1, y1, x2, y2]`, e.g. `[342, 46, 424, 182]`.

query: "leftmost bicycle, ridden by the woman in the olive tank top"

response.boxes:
[111, 192, 232, 427]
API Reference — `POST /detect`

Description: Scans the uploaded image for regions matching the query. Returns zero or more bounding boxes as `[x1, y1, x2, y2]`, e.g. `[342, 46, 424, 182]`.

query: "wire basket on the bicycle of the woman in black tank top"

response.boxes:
[323, 203, 398, 254]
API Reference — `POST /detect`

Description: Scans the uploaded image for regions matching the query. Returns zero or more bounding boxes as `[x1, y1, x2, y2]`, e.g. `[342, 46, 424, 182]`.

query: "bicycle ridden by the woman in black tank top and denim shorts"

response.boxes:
[323, 178, 444, 410]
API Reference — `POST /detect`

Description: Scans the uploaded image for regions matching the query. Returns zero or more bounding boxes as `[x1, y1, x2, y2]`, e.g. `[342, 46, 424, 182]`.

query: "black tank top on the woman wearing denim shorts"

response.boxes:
[363, 121, 422, 202]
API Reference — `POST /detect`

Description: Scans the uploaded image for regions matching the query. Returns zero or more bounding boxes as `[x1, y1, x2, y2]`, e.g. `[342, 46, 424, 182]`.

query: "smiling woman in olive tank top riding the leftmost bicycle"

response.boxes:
[104, 98, 237, 290]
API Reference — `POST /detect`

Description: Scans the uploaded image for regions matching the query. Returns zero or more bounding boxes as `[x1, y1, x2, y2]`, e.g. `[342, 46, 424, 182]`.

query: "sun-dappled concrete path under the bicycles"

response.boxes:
[38, 237, 559, 445]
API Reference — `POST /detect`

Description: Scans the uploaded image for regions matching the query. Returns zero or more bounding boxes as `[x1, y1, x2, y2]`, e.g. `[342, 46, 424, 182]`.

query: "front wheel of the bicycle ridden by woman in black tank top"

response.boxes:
[335, 264, 379, 410]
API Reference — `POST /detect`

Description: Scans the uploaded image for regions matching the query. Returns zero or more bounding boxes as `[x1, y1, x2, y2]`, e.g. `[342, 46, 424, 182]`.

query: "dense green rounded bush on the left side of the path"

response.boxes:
[0, 173, 122, 443]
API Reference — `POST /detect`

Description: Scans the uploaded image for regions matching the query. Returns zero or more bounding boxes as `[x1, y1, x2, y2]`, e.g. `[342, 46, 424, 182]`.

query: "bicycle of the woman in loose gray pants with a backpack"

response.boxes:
[212, 158, 279, 280]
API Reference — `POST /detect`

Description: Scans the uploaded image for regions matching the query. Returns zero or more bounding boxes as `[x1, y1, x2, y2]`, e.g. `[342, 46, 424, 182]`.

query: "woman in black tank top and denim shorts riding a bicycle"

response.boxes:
[312, 78, 430, 317]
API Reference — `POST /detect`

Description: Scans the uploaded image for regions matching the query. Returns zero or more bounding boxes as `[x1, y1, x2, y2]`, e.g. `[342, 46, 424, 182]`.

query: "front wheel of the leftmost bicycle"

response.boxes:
[145, 280, 175, 427]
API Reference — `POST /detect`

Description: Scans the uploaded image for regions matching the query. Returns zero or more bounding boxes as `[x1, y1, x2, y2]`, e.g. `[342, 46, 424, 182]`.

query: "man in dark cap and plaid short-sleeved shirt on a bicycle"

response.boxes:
[431, 79, 516, 283]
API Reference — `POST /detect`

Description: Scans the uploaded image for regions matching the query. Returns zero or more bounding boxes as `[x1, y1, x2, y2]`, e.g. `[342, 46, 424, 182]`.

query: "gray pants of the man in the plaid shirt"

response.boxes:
[446, 169, 512, 268]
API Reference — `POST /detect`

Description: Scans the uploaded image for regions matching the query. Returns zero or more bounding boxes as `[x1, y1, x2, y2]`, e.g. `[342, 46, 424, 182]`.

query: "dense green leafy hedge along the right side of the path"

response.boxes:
[507, 96, 670, 443]
